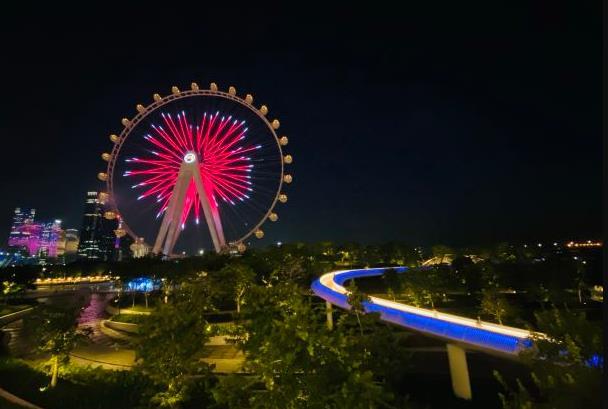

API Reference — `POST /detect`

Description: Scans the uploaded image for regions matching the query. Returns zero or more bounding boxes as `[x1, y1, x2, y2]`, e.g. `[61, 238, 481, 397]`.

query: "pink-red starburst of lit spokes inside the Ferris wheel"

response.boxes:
[125, 111, 254, 224]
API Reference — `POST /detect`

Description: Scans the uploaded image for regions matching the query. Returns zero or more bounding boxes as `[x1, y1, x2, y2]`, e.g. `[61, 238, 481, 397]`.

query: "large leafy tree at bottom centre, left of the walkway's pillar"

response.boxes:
[214, 281, 404, 409]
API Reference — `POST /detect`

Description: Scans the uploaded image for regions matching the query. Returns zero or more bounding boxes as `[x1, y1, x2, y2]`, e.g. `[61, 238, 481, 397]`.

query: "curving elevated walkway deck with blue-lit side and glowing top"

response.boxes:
[311, 267, 532, 355]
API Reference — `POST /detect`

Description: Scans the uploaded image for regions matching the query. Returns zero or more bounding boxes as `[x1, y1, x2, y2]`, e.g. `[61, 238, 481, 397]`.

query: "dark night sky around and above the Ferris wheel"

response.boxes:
[0, 0, 602, 246]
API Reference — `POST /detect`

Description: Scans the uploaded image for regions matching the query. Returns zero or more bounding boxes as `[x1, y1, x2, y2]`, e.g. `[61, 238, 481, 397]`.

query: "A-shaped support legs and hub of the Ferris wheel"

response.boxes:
[152, 152, 226, 256]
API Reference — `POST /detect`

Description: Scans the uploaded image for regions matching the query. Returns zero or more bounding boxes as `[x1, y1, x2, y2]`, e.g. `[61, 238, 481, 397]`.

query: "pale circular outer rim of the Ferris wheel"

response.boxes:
[105, 87, 286, 247]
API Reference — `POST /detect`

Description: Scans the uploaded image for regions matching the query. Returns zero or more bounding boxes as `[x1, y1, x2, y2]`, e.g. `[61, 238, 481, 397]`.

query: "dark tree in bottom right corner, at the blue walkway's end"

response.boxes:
[494, 309, 604, 409]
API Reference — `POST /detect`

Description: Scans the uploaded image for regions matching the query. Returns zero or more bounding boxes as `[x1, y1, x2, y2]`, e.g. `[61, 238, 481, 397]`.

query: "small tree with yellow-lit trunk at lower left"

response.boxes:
[24, 305, 91, 388]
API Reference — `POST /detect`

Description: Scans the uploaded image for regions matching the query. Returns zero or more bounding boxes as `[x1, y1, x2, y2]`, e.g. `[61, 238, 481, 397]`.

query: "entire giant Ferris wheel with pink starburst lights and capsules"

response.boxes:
[97, 82, 293, 256]
